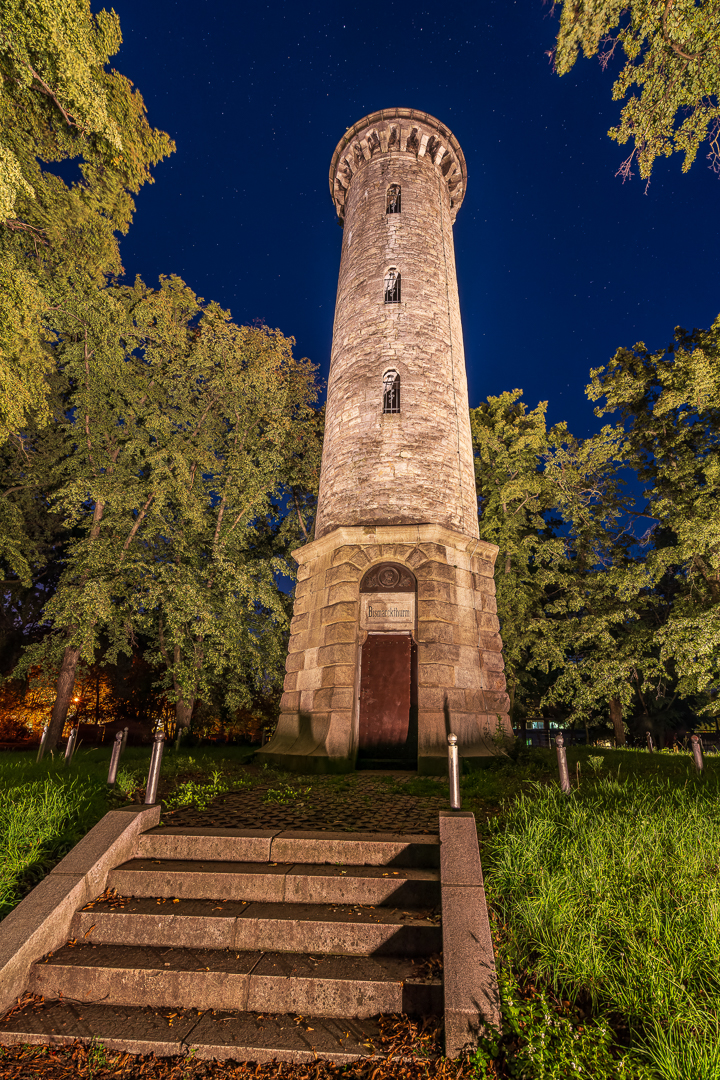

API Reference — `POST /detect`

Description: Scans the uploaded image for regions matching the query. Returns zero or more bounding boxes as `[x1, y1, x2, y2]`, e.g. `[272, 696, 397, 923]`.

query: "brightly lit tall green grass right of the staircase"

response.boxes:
[484, 771, 720, 1080]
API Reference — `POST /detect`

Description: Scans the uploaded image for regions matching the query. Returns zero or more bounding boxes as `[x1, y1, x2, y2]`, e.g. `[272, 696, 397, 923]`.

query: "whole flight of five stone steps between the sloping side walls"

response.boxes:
[0, 826, 444, 1062]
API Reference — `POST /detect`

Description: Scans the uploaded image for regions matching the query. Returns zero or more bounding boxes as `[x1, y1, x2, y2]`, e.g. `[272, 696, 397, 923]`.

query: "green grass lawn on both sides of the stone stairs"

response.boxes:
[0, 746, 720, 1080]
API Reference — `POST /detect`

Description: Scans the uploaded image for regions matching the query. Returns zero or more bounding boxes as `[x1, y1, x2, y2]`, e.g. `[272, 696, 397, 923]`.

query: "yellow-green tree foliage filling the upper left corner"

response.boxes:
[0, 0, 174, 438]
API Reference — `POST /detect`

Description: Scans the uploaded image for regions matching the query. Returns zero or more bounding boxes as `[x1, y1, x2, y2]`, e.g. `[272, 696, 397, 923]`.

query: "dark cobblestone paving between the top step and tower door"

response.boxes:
[163, 772, 449, 834]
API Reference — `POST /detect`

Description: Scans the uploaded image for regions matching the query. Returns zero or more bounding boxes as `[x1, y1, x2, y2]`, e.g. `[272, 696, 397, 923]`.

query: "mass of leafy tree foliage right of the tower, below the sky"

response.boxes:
[472, 308, 720, 742]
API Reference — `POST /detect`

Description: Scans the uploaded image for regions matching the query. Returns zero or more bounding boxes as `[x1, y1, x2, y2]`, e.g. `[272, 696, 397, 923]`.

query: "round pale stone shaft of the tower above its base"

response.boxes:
[315, 110, 478, 537]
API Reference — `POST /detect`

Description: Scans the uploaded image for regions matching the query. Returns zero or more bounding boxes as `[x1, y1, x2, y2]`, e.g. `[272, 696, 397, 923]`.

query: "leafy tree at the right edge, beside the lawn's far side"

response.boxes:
[588, 318, 720, 717]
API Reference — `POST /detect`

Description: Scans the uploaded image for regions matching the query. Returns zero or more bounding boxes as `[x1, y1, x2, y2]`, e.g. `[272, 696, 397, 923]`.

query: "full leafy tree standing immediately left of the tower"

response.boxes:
[7, 279, 316, 746]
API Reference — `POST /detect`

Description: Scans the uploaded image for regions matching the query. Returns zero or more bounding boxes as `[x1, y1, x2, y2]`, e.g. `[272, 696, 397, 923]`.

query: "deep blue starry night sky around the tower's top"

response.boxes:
[112, 0, 720, 435]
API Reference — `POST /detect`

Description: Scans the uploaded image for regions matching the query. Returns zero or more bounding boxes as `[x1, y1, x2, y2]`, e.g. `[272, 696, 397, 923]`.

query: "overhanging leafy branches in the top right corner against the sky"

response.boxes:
[553, 0, 720, 179]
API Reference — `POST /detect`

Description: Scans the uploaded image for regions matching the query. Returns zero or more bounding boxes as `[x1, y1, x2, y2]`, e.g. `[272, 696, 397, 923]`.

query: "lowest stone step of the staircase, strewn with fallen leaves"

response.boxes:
[0, 1001, 399, 1064]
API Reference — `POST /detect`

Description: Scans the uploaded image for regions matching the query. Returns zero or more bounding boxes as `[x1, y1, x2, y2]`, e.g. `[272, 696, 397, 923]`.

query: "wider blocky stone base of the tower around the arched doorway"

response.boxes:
[258, 525, 512, 773]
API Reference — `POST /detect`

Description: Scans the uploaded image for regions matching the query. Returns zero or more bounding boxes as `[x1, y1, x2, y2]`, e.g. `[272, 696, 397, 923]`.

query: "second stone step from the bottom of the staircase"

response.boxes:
[28, 945, 443, 1020]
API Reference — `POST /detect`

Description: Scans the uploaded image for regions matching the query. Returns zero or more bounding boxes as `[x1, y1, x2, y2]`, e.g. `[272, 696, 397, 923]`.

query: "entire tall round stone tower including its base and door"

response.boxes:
[260, 109, 510, 772]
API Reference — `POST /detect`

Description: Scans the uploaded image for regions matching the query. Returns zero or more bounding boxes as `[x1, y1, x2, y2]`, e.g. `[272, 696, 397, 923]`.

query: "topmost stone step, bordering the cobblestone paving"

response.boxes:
[137, 826, 439, 868]
